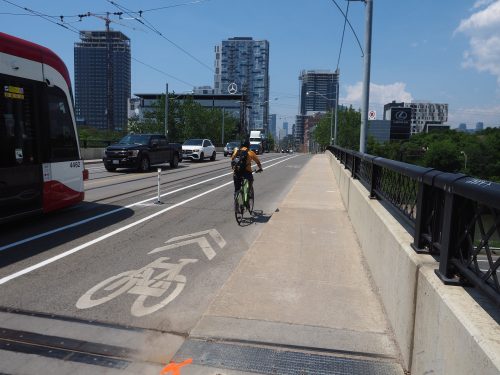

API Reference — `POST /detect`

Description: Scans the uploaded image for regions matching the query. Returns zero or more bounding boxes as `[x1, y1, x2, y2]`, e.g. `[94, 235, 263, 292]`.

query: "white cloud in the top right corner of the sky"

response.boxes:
[455, 0, 500, 85]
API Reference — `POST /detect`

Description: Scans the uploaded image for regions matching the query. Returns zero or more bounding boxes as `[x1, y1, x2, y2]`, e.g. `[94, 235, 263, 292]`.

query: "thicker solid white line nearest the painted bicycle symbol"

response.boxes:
[0, 156, 295, 285]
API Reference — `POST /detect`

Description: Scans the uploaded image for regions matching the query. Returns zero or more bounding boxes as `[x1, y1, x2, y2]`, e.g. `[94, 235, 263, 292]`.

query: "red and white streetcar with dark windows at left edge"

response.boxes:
[0, 33, 87, 222]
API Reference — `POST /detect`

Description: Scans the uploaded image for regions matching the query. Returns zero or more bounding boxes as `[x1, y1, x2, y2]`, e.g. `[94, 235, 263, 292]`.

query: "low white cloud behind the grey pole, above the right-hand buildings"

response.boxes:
[340, 82, 413, 105]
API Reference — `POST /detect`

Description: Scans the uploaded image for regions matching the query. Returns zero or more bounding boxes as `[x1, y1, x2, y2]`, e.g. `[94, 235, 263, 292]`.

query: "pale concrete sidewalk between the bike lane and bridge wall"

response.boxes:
[177, 155, 403, 374]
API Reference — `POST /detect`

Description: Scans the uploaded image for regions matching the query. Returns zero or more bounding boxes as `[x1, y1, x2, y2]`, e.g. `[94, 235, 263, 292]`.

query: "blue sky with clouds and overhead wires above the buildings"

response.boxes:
[0, 0, 500, 131]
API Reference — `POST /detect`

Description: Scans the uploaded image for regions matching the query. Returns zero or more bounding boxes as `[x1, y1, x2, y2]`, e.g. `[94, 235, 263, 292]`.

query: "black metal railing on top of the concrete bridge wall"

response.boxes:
[328, 146, 500, 306]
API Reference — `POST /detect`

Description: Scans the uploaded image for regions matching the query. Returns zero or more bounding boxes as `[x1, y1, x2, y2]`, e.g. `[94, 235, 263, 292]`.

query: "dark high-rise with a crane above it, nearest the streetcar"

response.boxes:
[74, 30, 131, 130]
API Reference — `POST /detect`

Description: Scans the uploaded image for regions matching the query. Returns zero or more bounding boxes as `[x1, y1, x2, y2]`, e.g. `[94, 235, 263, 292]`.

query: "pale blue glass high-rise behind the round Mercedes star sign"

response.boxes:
[214, 37, 269, 133]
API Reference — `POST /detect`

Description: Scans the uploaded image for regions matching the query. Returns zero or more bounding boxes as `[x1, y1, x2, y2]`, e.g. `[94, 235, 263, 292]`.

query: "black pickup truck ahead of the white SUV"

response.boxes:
[102, 134, 182, 172]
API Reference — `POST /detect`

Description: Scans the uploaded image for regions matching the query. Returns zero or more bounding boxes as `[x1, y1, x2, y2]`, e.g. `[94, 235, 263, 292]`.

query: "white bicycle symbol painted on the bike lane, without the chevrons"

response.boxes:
[76, 257, 198, 317]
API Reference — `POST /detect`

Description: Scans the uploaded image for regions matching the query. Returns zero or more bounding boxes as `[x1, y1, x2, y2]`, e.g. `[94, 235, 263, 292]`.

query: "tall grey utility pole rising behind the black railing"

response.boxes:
[359, 0, 373, 153]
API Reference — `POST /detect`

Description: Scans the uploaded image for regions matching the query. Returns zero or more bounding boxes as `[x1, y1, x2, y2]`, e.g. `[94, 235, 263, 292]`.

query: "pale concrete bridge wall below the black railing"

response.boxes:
[327, 151, 500, 375]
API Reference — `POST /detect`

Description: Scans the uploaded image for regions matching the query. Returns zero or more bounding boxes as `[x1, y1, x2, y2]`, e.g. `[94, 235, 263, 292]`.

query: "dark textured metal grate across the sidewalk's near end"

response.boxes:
[174, 339, 403, 375]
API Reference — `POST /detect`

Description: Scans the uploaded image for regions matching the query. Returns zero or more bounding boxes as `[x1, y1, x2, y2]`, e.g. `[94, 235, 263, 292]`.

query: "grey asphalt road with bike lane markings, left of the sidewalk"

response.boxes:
[0, 154, 309, 373]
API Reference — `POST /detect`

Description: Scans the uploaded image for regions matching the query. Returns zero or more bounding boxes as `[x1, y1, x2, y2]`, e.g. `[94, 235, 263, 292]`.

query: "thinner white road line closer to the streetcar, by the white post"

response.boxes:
[0, 158, 292, 251]
